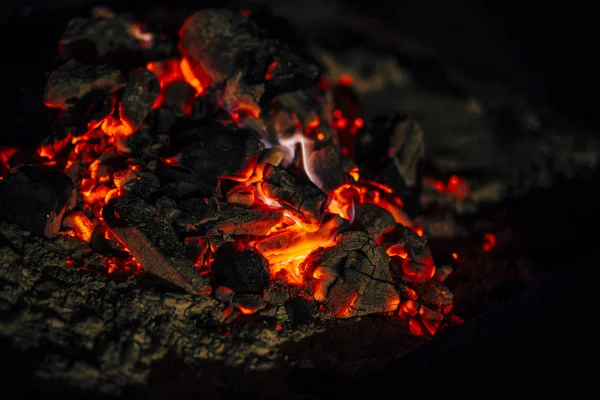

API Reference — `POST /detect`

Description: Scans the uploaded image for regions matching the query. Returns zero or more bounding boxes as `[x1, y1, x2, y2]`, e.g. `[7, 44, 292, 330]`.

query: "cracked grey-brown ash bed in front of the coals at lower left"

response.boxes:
[0, 222, 424, 398]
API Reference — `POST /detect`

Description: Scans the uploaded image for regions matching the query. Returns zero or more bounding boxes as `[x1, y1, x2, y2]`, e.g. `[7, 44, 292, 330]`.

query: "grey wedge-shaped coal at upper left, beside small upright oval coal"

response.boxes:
[44, 60, 125, 110]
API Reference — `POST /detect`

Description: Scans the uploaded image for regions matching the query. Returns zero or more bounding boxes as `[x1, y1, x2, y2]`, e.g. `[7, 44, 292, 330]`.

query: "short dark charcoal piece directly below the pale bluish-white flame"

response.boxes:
[260, 164, 327, 225]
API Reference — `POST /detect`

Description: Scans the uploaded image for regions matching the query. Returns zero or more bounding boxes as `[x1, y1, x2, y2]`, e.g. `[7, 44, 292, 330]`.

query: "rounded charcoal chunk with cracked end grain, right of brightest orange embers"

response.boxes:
[302, 232, 400, 318]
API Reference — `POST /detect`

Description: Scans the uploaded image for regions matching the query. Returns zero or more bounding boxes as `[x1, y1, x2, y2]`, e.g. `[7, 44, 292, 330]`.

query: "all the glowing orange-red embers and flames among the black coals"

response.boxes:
[0, 7, 460, 335]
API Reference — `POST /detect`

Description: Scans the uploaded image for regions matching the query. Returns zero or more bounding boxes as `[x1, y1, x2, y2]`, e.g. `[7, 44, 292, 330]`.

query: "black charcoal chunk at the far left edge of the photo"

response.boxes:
[0, 165, 75, 237]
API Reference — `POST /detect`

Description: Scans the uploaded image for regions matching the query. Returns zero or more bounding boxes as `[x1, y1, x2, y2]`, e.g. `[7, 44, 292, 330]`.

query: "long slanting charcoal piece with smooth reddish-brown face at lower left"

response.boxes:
[102, 195, 211, 295]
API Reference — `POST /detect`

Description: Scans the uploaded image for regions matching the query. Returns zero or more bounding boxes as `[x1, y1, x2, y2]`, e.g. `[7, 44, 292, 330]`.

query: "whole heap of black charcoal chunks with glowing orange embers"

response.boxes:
[0, 10, 458, 335]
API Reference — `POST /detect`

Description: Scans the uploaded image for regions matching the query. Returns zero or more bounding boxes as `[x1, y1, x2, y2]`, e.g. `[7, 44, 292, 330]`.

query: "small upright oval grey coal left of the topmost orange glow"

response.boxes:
[121, 68, 160, 127]
